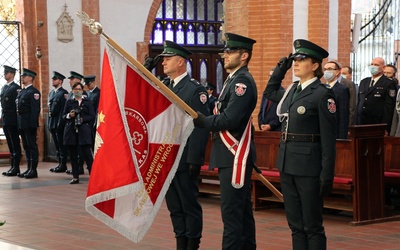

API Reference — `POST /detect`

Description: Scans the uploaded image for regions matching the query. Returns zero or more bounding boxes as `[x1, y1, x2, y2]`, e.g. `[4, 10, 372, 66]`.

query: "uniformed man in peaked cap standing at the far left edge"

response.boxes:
[0, 65, 21, 176]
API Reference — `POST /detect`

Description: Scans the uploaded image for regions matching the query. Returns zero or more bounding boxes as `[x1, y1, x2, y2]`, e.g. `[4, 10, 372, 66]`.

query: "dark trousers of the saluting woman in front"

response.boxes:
[280, 172, 326, 250]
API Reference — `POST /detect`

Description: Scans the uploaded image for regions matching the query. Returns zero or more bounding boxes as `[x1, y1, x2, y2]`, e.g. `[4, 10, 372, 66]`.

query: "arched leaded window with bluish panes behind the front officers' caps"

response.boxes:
[150, 0, 226, 94]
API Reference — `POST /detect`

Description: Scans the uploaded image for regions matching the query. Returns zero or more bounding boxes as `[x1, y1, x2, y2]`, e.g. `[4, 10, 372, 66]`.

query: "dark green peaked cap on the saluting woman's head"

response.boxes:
[292, 39, 329, 62]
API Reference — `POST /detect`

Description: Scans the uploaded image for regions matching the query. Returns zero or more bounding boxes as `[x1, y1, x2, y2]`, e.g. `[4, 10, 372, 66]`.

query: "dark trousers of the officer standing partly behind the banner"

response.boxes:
[165, 167, 203, 239]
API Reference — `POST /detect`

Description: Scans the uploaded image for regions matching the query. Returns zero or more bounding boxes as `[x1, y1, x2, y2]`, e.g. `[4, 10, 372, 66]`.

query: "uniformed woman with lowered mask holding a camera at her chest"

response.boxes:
[63, 82, 95, 184]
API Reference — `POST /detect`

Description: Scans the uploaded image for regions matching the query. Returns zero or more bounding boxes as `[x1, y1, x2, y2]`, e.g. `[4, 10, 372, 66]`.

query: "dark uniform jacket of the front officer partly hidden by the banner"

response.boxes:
[168, 75, 209, 171]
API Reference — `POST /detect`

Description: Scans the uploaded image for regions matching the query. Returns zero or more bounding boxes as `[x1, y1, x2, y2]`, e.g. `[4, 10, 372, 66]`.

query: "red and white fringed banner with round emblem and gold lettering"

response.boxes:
[86, 45, 193, 242]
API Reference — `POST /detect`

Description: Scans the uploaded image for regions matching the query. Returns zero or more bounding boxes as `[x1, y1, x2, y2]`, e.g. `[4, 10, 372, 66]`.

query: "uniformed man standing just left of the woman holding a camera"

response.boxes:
[47, 71, 68, 173]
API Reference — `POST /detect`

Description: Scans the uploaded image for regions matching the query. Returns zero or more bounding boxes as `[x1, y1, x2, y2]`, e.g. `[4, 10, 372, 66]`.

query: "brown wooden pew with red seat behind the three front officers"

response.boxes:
[199, 124, 400, 225]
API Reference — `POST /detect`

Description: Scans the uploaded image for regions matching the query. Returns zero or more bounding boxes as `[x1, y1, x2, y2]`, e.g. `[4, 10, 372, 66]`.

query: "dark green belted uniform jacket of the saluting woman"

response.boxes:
[264, 77, 336, 180]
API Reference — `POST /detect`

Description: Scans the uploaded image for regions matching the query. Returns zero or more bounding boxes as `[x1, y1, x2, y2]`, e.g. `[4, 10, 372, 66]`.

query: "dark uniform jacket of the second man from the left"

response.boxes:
[16, 85, 40, 129]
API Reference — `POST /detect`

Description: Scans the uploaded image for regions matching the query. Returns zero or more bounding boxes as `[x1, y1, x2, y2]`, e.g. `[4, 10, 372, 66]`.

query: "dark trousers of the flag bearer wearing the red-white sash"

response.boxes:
[218, 166, 256, 250]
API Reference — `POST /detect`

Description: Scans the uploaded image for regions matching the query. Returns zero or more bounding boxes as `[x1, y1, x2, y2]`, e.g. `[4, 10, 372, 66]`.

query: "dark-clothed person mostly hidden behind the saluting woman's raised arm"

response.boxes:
[258, 68, 283, 131]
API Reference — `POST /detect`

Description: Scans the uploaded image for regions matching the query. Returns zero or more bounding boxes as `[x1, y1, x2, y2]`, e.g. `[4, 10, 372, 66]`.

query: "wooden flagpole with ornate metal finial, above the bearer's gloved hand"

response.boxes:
[76, 11, 198, 118]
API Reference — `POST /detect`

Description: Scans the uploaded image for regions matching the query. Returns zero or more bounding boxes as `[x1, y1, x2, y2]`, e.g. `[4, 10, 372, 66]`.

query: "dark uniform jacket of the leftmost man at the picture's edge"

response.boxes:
[0, 82, 21, 126]
